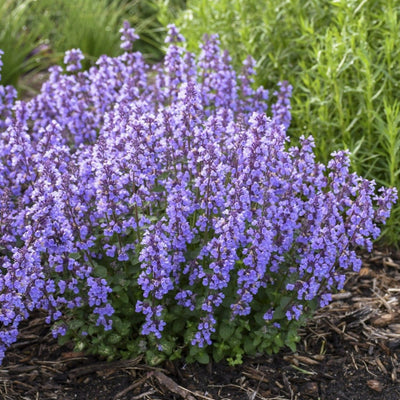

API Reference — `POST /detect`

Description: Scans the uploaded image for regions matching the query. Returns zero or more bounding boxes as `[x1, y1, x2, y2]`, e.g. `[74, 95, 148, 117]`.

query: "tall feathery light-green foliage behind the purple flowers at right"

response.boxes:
[159, 0, 400, 245]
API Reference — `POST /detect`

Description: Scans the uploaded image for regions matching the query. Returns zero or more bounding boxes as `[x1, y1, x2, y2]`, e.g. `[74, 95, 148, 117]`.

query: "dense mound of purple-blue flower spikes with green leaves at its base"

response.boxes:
[0, 24, 396, 362]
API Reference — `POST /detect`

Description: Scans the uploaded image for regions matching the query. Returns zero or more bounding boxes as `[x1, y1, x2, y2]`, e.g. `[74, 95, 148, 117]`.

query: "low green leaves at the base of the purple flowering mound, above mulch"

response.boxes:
[59, 238, 317, 365]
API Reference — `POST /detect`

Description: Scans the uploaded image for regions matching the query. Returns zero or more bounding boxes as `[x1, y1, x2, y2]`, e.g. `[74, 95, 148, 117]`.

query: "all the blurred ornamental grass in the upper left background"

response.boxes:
[0, 0, 164, 91]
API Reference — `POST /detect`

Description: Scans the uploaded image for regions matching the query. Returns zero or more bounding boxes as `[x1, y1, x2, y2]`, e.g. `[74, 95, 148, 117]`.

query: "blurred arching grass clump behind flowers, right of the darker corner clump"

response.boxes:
[29, 0, 162, 67]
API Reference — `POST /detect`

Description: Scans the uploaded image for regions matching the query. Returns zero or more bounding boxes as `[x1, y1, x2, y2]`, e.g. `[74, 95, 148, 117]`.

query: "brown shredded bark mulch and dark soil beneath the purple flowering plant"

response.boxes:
[0, 250, 400, 400]
